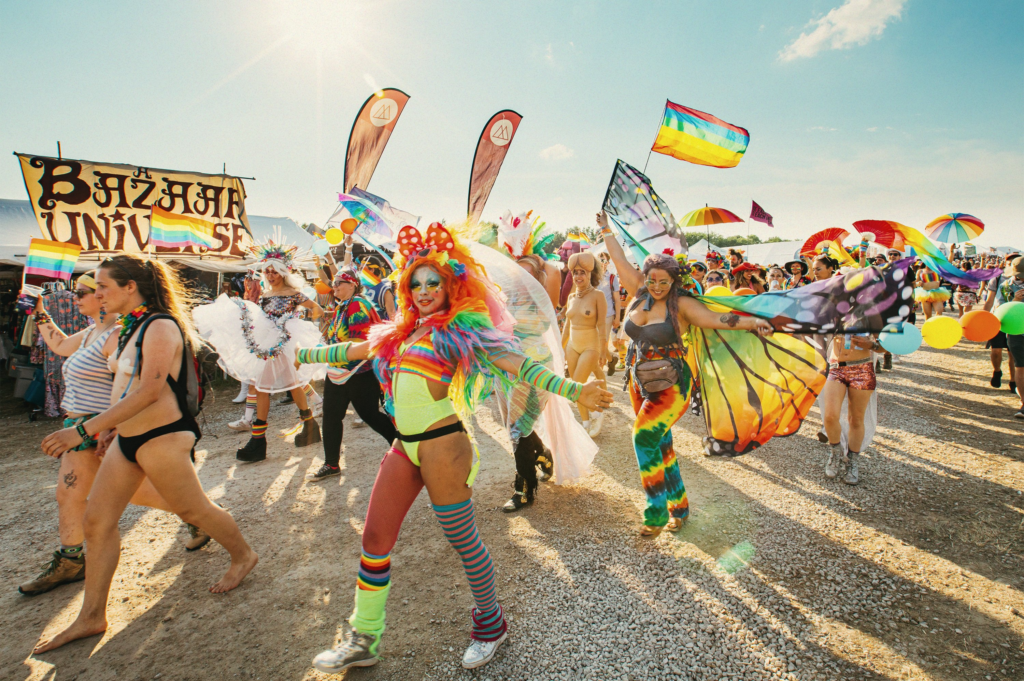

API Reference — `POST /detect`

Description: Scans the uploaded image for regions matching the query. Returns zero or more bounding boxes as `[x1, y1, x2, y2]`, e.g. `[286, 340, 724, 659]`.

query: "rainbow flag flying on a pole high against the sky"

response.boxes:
[651, 100, 751, 168]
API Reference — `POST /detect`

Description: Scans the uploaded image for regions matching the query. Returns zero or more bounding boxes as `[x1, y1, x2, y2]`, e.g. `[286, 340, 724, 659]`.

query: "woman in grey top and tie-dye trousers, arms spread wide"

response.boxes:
[597, 212, 772, 537]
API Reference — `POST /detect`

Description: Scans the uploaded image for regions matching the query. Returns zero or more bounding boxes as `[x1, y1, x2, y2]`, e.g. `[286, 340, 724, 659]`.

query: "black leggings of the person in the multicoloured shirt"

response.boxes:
[324, 372, 398, 467]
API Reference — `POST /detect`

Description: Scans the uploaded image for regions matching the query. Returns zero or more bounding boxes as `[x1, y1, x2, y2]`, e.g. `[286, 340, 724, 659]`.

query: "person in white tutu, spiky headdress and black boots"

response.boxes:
[193, 240, 325, 463]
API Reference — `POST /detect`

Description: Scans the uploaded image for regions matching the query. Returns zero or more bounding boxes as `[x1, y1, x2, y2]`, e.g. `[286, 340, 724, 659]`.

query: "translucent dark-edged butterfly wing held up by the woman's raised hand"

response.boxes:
[604, 160, 686, 264]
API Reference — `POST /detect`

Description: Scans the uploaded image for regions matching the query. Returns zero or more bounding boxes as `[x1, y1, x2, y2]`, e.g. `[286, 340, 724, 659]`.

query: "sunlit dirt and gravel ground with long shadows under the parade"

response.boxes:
[0, 325, 1024, 681]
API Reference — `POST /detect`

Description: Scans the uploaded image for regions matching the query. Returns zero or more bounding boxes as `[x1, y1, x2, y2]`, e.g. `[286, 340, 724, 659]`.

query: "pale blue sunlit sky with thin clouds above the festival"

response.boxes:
[0, 0, 1024, 247]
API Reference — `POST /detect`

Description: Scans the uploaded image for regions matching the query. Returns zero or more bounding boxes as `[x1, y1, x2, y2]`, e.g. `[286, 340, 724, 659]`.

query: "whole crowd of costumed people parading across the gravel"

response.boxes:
[19, 213, 1024, 673]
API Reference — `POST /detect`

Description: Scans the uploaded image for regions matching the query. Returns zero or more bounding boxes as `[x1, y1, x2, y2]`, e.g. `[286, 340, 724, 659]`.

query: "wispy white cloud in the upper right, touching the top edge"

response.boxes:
[778, 0, 906, 61]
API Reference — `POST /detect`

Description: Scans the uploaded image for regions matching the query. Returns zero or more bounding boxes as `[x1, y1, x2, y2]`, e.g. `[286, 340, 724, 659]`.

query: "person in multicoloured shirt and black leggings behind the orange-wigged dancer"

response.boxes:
[307, 268, 397, 480]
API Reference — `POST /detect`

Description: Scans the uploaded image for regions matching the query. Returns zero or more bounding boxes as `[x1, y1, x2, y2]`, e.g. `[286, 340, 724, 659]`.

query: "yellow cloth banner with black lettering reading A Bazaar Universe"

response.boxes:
[15, 154, 253, 257]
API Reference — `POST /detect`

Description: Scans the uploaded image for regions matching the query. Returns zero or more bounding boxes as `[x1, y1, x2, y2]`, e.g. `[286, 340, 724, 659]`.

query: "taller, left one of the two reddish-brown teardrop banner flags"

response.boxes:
[345, 87, 409, 194]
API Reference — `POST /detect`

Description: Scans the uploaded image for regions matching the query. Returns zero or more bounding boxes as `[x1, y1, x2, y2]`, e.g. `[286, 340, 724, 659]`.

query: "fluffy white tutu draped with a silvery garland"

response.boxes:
[193, 294, 327, 392]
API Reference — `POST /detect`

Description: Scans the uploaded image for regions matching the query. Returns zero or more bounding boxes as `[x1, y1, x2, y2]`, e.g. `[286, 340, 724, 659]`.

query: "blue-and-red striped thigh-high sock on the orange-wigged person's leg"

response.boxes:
[434, 499, 508, 641]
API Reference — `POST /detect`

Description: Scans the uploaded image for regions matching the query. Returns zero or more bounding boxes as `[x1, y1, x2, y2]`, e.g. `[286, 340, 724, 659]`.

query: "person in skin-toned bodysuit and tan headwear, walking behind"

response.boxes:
[562, 251, 608, 437]
